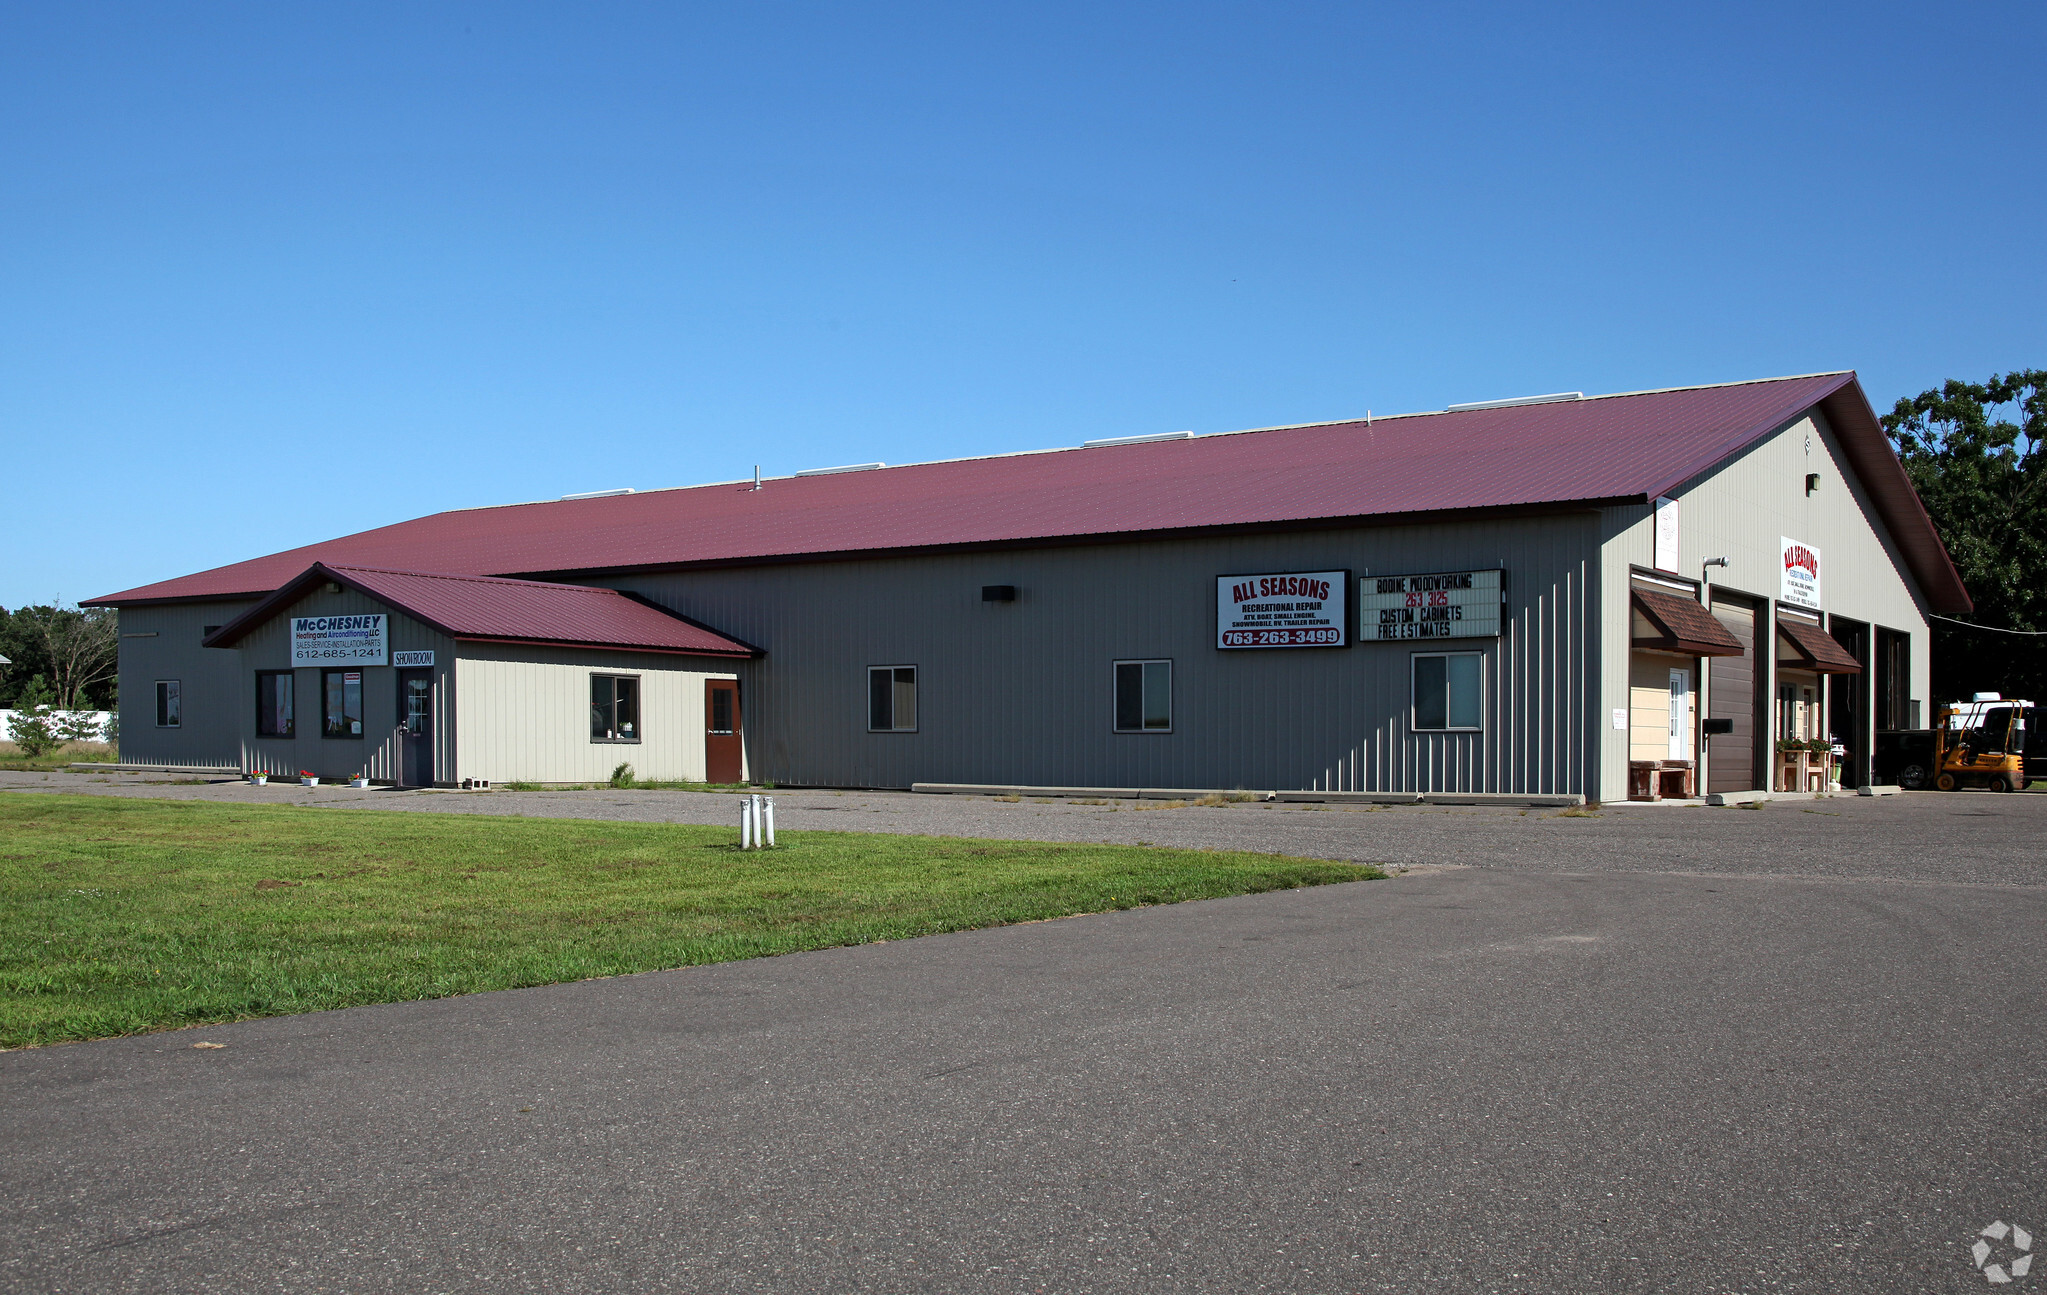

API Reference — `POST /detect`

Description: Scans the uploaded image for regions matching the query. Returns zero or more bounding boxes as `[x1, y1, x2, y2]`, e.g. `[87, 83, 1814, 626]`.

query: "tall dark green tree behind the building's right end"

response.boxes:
[1883, 368, 2047, 702]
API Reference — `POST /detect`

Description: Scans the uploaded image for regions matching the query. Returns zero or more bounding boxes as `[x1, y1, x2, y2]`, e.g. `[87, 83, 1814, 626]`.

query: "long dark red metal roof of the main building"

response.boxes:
[96, 372, 1967, 610]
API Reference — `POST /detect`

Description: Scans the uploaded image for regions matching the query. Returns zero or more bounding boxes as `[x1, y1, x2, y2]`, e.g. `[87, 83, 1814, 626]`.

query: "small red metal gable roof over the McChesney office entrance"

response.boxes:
[207, 563, 757, 657]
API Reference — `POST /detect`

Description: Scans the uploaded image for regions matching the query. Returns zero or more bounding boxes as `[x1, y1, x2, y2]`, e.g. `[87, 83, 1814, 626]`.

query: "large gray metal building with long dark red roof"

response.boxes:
[94, 372, 1969, 800]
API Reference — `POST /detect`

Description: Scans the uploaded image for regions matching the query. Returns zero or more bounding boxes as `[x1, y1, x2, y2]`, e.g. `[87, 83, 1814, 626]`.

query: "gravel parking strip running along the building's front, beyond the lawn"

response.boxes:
[0, 773, 2047, 886]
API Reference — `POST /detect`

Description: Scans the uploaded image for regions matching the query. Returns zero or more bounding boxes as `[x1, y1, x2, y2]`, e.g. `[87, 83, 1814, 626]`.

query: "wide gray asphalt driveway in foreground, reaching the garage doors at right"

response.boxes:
[0, 773, 2047, 1293]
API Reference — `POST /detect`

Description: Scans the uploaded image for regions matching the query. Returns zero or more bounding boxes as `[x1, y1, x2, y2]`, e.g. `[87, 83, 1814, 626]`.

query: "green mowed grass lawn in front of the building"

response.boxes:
[0, 792, 1384, 1047]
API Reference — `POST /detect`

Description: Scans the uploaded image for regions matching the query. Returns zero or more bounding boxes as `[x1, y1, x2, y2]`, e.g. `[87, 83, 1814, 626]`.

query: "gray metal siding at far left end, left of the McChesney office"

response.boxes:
[121, 601, 254, 769]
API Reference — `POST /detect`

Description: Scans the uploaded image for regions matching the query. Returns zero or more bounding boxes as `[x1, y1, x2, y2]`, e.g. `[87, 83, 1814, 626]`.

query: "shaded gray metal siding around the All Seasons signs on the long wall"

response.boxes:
[604, 509, 1599, 794]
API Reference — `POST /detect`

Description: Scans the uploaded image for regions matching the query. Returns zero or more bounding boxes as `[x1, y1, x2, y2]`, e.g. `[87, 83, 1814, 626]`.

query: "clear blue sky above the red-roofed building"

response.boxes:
[0, 2, 2047, 608]
